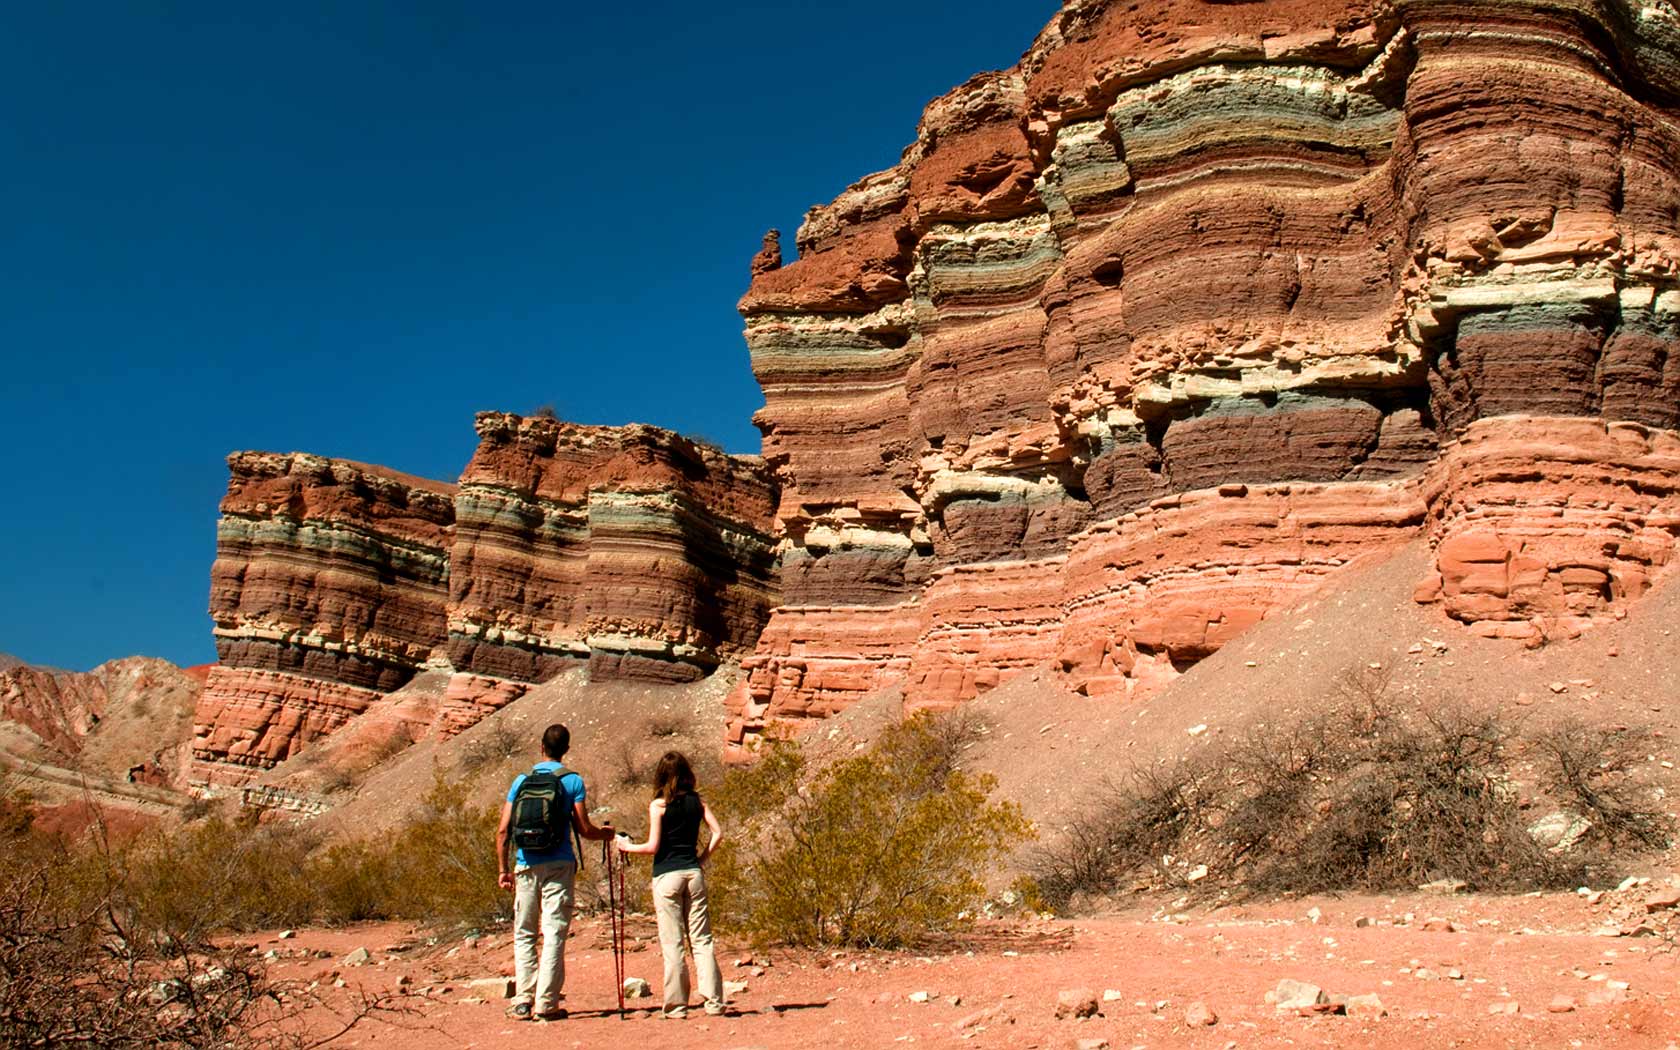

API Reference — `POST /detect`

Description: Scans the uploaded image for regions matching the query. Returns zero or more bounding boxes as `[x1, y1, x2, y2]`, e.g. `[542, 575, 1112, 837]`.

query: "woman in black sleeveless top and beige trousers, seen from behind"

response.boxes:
[617, 751, 724, 1018]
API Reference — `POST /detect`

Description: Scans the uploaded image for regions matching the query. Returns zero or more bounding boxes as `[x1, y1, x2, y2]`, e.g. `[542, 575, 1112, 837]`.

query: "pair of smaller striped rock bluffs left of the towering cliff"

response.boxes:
[193, 413, 776, 790]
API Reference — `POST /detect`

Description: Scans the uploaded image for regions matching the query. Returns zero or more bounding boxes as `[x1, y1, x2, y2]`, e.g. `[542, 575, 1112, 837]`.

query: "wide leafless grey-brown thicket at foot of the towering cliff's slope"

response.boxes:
[1030, 674, 1672, 909]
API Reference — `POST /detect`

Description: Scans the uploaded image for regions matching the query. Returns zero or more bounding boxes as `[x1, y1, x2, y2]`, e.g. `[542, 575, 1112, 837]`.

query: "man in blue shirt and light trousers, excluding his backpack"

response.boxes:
[496, 724, 613, 1021]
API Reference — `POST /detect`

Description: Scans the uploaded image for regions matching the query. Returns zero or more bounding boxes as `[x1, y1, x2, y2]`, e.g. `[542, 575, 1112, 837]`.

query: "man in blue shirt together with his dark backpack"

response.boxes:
[496, 724, 613, 1021]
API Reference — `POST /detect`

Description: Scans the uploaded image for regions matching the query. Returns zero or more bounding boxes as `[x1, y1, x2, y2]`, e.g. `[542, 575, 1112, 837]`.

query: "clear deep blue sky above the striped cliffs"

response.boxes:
[0, 0, 1057, 669]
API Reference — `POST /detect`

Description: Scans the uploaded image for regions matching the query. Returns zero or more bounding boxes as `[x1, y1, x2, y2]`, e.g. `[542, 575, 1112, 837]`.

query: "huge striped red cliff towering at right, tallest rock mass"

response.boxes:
[731, 0, 1680, 744]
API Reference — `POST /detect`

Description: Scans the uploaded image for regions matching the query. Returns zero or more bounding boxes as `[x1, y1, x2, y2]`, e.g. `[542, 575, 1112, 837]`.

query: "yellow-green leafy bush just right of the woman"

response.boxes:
[707, 716, 1030, 948]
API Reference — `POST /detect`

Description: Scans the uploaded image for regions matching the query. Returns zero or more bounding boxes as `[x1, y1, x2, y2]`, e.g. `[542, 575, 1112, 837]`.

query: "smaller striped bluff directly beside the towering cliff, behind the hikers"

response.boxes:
[449, 413, 776, 729]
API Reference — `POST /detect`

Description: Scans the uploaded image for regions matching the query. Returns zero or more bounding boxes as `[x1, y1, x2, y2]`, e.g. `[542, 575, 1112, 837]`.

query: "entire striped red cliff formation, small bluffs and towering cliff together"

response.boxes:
[193, 0, 1680, 783]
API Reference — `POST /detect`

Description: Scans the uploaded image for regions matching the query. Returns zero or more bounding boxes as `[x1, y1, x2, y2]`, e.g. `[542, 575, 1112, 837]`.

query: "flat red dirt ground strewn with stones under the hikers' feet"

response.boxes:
[268, 890, 1680, 1050]
